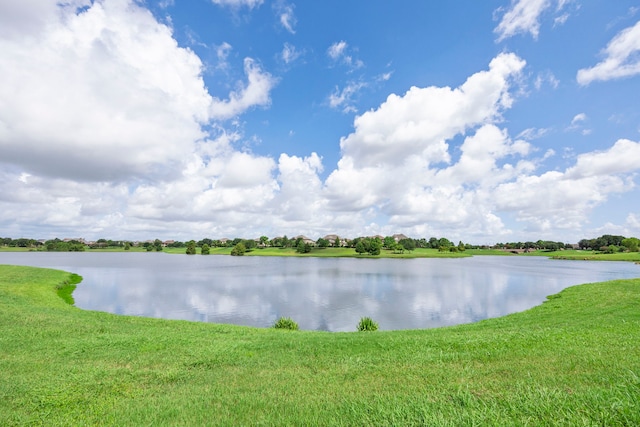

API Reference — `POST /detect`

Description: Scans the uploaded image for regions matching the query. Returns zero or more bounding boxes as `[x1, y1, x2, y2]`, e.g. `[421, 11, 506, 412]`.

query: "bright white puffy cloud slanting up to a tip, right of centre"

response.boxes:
[340, 54, 525, 167]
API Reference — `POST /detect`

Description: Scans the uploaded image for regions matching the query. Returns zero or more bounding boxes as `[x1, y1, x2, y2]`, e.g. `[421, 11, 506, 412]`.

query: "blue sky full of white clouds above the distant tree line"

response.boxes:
[0, 0, 640, 243]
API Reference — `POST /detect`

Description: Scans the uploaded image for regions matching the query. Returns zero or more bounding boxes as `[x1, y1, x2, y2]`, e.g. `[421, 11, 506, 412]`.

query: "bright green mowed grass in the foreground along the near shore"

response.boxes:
[0, 266, 640, 426]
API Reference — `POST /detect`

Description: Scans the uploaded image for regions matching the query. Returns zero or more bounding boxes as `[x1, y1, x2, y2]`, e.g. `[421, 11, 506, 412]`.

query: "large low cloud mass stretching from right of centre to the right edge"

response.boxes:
[325, 53, 640, 239]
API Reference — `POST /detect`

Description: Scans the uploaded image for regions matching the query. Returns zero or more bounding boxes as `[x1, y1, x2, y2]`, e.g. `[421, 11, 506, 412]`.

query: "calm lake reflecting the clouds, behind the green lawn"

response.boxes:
[0, 252, 640, 331]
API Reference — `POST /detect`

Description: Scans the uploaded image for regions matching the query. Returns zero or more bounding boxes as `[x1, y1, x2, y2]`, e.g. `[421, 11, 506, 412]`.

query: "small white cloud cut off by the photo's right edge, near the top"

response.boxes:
[577, 21, 640, 85]
